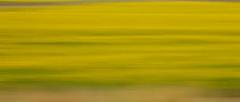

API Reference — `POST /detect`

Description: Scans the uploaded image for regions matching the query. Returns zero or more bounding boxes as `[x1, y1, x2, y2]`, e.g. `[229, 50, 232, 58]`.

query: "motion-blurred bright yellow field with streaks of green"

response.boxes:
[0, 2, 240, 88]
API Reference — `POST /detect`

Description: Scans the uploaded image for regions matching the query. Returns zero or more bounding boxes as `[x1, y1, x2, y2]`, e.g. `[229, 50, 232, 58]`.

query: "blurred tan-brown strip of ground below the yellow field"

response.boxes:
[0, 87, 240, 102]
